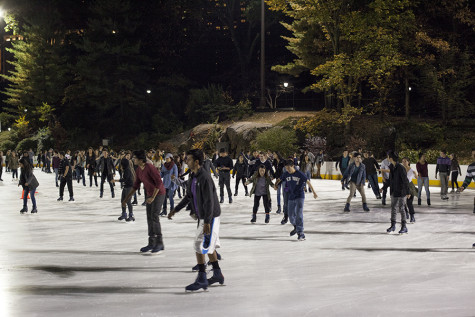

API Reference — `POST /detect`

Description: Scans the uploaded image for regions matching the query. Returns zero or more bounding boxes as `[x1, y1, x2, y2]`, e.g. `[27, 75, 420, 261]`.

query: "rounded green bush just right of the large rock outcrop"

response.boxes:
[251, 127, 297, 157]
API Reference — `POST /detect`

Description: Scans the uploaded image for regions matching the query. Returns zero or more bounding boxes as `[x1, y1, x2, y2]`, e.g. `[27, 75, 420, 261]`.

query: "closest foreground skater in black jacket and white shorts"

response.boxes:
[168, 149, 224, 291]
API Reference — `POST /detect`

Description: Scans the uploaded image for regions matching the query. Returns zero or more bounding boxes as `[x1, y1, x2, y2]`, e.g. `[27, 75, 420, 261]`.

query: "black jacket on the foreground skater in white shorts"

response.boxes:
[175, 167, 221, 224]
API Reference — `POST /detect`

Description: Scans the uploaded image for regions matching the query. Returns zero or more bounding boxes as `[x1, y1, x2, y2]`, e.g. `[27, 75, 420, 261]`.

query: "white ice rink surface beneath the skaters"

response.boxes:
[0, 169, 475, 317]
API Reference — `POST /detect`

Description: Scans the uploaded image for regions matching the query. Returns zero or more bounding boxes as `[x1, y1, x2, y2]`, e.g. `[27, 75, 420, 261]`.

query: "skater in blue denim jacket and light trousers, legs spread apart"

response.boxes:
[341, 153, 369, 212]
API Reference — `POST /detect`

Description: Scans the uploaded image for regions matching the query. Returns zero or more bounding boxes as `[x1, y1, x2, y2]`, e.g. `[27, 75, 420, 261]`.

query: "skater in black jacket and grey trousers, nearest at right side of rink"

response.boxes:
[381, 151, 411, 234]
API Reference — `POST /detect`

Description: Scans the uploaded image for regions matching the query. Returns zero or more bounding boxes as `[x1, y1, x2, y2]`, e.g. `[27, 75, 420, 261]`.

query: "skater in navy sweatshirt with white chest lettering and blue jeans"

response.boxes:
[274, 160, 318, 241]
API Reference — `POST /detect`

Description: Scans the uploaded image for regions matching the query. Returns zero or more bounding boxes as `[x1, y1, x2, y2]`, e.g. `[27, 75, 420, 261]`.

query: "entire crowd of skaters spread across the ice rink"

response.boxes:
[0, 147, 475, 290]
